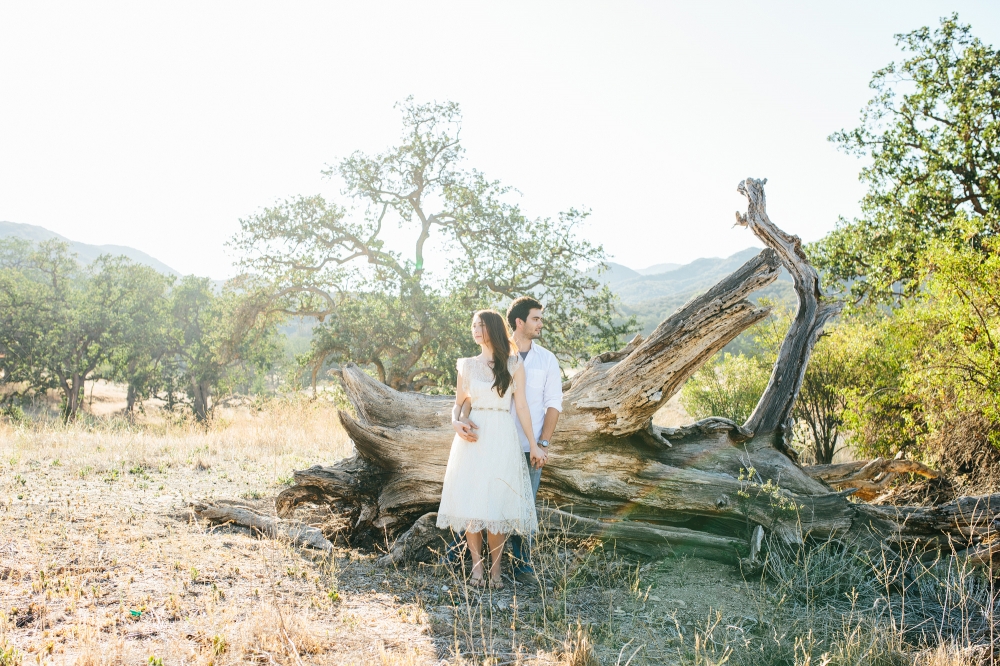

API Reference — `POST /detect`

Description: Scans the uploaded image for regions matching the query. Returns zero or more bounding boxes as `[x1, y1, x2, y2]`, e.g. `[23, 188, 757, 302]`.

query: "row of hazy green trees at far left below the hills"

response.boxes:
[0, 239, 279, 421]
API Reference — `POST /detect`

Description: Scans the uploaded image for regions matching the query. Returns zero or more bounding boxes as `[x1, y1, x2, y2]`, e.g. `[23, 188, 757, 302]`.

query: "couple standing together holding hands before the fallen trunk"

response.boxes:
[437, 296, 562, 589]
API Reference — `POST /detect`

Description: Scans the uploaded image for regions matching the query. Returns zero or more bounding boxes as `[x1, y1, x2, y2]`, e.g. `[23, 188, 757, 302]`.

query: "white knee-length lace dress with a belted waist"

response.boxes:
[437, 354, 538, 534]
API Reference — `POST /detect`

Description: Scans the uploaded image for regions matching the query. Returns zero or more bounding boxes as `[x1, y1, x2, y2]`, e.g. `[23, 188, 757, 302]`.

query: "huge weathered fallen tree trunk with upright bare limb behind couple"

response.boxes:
[277, 179, 1000, 561]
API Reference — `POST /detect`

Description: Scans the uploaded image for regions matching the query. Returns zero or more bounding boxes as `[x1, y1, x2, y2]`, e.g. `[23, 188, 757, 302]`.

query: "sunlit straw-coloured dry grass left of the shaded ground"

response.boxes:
[0, 402, 446, 666]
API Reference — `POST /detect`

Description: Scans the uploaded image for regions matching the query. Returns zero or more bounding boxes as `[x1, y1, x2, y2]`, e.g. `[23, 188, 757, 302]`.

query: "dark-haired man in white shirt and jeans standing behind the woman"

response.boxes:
[453, 296, 562, 580]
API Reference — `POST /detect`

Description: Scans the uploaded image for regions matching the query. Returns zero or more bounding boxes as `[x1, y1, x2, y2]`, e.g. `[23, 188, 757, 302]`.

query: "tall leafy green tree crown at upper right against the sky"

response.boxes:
[811, 15, 1000, 302]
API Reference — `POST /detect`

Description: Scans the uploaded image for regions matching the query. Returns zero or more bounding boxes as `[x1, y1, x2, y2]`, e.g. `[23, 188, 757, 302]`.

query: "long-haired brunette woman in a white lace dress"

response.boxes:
[437, 310, 542, 589]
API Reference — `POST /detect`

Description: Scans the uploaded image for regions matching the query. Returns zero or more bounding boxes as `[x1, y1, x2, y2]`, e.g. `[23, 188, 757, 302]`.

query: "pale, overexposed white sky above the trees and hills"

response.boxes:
[0, 0, 1000, 278]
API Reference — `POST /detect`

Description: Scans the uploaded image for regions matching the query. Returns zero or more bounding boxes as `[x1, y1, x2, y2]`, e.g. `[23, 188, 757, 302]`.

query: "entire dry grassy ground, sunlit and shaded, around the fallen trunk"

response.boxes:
[0, 396, 996, 666]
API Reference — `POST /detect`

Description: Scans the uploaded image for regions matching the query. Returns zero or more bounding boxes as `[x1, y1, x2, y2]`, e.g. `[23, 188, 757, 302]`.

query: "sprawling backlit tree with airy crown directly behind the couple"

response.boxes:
[233, 99, 634, 390]
